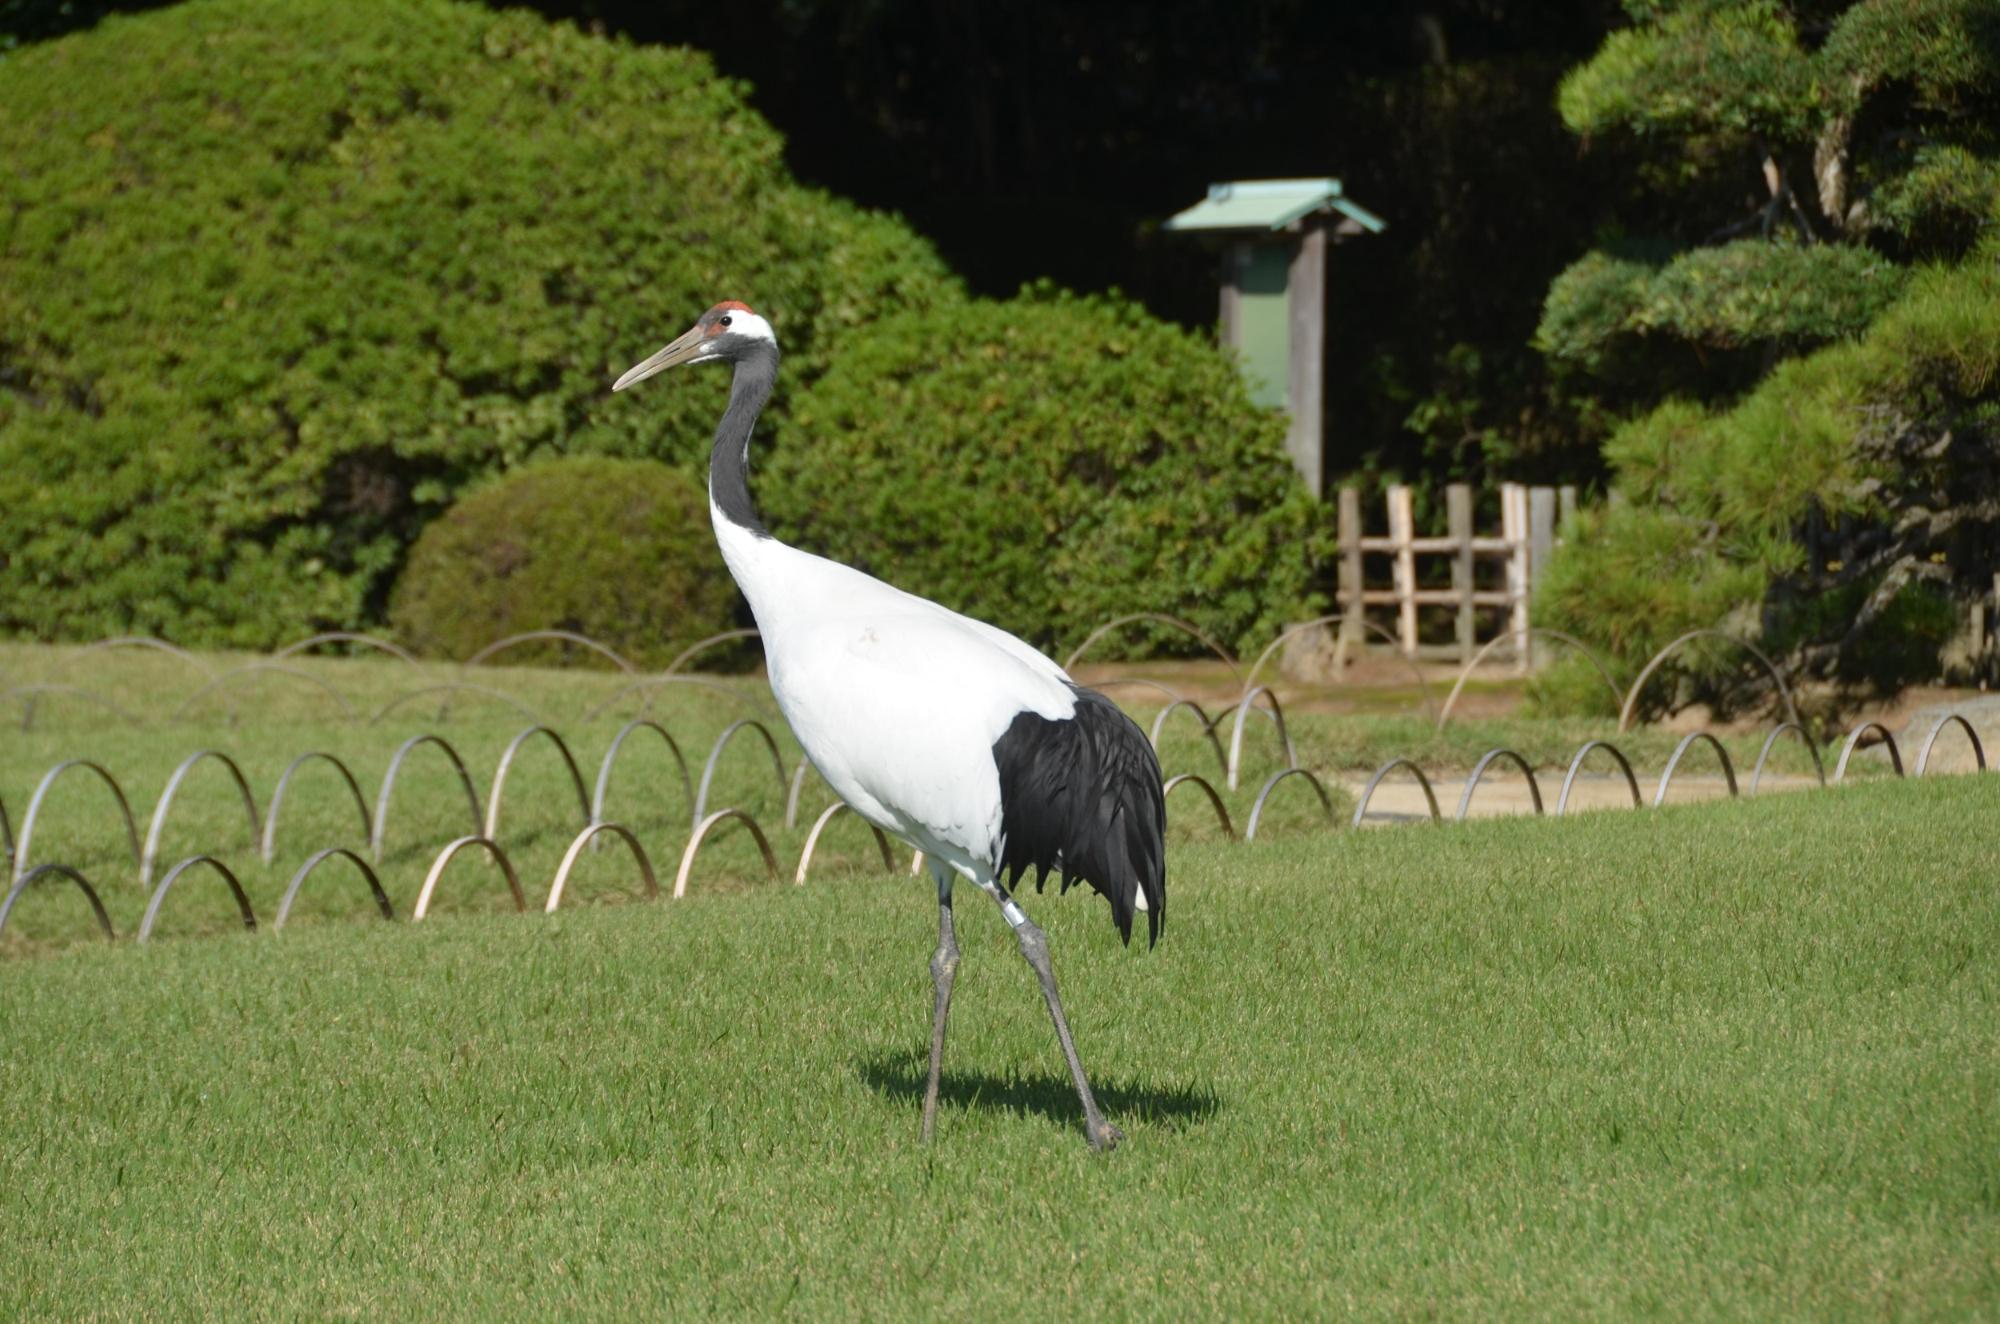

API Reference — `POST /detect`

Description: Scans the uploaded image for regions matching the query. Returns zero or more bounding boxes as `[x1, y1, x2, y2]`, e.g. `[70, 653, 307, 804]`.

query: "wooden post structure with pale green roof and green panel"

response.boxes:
[1164, 178, 1386, 496]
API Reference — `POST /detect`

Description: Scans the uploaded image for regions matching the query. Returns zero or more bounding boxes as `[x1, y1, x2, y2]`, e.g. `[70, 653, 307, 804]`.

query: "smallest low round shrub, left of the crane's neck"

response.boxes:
[390, 458, 736, 666]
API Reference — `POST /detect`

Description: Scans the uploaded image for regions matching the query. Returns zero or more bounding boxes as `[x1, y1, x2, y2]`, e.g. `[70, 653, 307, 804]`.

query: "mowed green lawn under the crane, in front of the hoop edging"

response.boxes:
[0, 776, 2000, 1318]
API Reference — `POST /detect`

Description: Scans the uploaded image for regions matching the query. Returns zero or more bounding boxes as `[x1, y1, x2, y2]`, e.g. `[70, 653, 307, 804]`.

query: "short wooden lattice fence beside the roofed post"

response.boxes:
[1338, 482, 1576, 670]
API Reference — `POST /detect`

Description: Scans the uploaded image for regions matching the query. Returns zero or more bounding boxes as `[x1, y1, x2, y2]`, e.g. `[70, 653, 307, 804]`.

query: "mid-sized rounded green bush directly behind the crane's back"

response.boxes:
[758, 290, 1326, 652]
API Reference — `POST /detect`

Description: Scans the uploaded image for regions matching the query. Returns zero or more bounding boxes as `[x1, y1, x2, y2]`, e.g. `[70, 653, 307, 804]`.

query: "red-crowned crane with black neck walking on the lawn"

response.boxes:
[612, 300, 1166, 1150]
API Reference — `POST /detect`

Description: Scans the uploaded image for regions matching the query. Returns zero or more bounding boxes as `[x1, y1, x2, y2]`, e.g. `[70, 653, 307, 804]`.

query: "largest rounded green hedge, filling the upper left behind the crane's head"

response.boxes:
[0, 0, 956, 646]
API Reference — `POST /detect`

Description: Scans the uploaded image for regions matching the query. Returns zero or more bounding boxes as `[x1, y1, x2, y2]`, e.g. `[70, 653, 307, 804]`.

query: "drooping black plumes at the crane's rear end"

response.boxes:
[994, 684, 1166, 944]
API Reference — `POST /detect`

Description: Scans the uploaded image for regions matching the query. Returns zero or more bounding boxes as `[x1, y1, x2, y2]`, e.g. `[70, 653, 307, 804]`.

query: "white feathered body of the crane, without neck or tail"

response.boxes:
[710, 504, 1076, 884]
